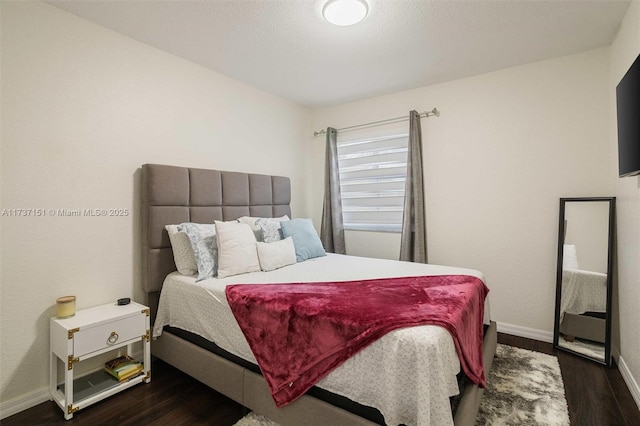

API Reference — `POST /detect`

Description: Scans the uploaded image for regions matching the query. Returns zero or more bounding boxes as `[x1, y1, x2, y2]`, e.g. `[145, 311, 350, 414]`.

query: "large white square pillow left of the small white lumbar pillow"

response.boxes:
[216, 221, 260, 278]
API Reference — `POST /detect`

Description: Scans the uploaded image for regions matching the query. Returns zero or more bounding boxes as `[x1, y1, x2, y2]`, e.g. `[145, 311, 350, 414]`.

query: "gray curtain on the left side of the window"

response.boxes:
[320, 127, 346, 254]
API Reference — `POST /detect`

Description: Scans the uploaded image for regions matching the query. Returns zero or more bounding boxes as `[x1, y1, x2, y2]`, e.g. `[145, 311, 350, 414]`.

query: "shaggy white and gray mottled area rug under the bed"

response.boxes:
[235, 344, 569, 426]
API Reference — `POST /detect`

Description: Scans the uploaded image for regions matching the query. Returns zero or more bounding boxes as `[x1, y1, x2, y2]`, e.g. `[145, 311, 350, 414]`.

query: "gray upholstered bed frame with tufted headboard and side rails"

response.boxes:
[141, 164, 497, 426]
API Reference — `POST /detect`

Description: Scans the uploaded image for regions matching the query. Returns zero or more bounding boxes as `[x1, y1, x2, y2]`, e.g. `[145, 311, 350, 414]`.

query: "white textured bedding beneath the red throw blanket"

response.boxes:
[153, 254, 490, 426]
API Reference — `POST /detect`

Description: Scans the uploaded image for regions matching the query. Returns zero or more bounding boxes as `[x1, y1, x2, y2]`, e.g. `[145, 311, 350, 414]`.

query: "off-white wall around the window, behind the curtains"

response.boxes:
[307, 48, 614, 336]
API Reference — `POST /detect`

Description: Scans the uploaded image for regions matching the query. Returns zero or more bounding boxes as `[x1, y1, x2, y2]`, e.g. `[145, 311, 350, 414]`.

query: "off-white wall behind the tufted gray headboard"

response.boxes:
[0, 2, 310, 410]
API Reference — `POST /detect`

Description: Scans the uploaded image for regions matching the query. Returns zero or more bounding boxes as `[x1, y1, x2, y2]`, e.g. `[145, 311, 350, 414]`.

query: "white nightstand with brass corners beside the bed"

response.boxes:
[49, 302, 151, 420]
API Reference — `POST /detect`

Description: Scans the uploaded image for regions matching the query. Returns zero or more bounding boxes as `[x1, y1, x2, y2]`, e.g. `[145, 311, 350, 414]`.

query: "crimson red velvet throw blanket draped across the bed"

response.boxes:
[226, 275, 489, 407]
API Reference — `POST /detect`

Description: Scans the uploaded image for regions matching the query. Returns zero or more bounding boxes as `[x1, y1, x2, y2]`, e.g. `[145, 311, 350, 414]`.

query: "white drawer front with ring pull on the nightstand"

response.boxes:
[73, 314, 147, 357]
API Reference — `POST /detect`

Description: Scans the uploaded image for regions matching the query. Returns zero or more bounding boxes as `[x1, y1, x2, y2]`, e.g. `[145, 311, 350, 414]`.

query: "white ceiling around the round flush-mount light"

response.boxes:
[47, 0, 630, 107]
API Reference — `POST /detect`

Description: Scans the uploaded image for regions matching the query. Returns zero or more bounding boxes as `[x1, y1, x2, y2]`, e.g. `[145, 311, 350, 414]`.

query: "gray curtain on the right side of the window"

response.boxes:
[400, 111, 427, 263]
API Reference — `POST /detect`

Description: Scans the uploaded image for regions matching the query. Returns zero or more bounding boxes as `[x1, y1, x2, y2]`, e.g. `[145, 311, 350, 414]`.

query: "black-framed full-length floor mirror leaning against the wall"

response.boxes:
[553, 197, 616, 366]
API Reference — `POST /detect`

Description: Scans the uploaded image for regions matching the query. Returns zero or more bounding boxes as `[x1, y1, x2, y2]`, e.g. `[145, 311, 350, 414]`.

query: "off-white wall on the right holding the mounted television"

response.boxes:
[608, 0, 640, 407]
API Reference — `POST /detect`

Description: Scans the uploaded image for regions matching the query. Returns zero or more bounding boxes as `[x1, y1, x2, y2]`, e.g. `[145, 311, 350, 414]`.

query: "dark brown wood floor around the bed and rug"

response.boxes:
[1, 334, 640, 426]
